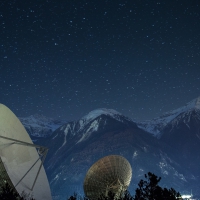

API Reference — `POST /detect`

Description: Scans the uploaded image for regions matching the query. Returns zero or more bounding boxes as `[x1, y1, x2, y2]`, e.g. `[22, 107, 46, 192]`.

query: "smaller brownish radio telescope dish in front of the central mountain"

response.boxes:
[83, 155, 132, 200]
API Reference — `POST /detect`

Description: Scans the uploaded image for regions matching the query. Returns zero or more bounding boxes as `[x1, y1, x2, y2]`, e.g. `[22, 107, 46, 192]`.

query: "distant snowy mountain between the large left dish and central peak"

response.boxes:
[19, 114, 66, 140]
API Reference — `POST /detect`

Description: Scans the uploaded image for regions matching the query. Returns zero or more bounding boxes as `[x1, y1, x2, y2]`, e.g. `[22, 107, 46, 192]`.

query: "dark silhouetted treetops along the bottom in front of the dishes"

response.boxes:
[0, 172, 181, 200]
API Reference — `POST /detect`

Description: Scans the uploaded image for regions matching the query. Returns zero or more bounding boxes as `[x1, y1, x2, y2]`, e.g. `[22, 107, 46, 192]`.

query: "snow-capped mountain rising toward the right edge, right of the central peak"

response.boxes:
[138, 97, 200, 195]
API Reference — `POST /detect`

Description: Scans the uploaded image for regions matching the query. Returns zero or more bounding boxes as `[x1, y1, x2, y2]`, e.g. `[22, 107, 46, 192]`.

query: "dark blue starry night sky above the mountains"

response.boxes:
[0, 0, 200, 120]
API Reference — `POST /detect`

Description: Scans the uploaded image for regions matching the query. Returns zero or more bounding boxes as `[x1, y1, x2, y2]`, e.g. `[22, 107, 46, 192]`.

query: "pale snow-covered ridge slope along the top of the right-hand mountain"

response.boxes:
[137, 97, 200, 137]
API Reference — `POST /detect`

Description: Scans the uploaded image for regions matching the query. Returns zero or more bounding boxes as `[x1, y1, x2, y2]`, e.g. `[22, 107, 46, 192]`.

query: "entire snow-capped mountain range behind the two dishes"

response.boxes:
[20, 97, 200, 199]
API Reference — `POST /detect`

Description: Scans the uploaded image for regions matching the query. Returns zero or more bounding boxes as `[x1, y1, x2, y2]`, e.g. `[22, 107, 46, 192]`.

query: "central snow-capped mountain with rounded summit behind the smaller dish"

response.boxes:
[36, 109, 193, 200]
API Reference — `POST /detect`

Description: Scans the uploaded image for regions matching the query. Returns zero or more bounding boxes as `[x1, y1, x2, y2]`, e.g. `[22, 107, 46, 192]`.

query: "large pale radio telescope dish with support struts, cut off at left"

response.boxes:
[0, 104, 52, 200]
